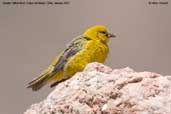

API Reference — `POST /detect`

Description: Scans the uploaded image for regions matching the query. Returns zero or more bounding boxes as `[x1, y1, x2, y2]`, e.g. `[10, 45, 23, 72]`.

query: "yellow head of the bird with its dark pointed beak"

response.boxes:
[84, 25, 115, 43]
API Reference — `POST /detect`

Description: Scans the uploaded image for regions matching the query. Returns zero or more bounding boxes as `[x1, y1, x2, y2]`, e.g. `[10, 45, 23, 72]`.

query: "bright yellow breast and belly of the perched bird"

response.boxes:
[64, 40, 109, 77]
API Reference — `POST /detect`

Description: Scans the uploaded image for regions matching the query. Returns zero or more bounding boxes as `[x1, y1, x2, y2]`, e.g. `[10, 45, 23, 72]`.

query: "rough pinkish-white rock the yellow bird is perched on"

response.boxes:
[24, 63, 171, 114]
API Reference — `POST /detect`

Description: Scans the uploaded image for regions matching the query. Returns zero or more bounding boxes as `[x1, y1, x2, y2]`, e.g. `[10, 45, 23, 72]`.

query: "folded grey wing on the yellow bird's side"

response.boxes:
[53, 36, 89, 73]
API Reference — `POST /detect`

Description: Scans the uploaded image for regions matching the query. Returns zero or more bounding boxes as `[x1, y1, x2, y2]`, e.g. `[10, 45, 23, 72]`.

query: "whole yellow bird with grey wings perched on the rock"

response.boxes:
[27, 25, 115, 91]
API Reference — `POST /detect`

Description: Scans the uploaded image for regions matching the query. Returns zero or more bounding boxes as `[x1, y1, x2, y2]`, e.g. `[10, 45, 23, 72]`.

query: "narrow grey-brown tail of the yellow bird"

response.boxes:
[27, 71, 51, 91]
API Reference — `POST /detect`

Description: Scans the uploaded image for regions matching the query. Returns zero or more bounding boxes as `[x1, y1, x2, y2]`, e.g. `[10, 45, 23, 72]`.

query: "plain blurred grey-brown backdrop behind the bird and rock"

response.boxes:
[0, 0, 171, 114]
